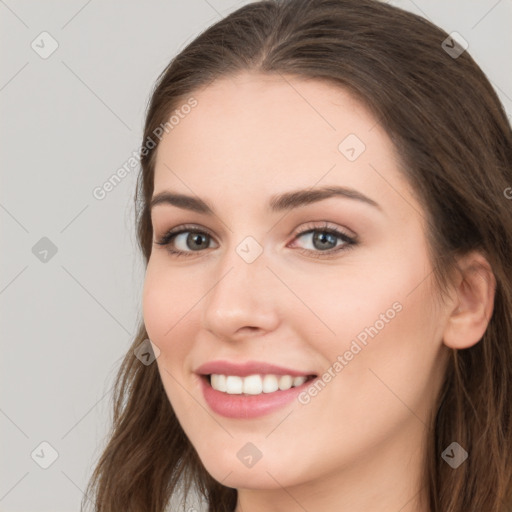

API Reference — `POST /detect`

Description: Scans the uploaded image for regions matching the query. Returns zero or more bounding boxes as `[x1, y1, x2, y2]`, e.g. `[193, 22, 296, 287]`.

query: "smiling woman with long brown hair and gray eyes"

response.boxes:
[82, 0, 512, 512]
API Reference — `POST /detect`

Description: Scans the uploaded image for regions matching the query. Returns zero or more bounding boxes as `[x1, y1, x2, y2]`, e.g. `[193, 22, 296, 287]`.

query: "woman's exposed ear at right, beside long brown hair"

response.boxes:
[443, 252, 496, 349]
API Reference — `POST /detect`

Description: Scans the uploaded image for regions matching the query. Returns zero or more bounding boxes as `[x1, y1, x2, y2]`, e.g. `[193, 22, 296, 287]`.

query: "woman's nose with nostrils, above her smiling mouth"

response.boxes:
[202, 243, 283, 340]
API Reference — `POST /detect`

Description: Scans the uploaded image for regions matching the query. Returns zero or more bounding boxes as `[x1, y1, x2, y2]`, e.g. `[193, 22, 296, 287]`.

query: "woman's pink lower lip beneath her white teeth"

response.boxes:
[200, 376, 313, 419]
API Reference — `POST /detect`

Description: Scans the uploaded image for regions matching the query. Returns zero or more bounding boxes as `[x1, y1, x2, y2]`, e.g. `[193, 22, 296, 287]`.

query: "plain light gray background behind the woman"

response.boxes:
[0, 0, 512, 512]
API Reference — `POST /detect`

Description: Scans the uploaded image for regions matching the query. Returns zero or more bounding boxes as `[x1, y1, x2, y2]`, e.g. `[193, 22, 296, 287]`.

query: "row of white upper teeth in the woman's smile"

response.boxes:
[210, 374, 307, 395]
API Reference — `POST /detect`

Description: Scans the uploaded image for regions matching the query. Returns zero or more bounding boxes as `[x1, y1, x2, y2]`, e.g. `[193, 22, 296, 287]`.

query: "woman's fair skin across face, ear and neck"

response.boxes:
[143, 72, 493, 512]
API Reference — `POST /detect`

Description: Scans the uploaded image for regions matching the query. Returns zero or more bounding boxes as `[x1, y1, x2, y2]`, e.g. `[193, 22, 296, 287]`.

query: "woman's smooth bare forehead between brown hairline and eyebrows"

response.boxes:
[151, 73, 412, 218]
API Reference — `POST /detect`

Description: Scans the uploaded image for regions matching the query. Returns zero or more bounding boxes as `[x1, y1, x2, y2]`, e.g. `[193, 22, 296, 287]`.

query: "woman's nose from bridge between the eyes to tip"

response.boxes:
[203, 237, 277, 337]
